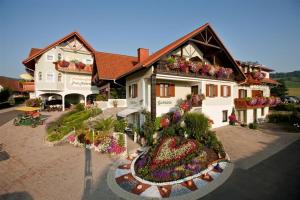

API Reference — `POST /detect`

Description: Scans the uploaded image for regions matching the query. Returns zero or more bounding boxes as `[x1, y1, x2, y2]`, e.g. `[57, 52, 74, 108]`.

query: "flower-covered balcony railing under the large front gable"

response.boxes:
[157, 61, 234, 81]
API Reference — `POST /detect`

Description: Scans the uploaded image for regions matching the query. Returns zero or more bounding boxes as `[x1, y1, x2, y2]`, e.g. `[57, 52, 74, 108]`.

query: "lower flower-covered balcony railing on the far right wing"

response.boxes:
[234, 97, 281, 109]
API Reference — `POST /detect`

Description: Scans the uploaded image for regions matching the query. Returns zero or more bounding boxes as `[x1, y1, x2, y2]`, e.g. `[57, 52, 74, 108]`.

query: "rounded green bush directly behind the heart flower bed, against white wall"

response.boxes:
[184, 113, 209, 140]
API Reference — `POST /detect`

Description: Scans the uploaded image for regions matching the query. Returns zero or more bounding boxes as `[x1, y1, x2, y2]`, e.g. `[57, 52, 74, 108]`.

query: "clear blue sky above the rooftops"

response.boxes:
[0, 0, 300, 77]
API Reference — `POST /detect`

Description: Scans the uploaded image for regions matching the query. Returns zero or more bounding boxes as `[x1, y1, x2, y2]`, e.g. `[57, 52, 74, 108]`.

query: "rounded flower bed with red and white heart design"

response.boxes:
[134, 136, 224, 183]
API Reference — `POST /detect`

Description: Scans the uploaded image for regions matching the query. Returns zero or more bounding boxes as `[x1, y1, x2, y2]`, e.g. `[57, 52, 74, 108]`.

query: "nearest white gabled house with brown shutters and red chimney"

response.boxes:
[98, 24, 276, 127]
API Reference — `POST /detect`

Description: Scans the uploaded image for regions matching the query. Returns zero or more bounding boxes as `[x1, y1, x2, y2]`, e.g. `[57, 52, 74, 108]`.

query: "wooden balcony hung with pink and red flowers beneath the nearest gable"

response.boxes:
[156, 61, 234, 81]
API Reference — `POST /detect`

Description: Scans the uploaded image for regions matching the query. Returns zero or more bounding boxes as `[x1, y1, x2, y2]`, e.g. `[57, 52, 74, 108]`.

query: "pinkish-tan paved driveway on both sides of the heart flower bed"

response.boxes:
[0, 113, 299, 200]
